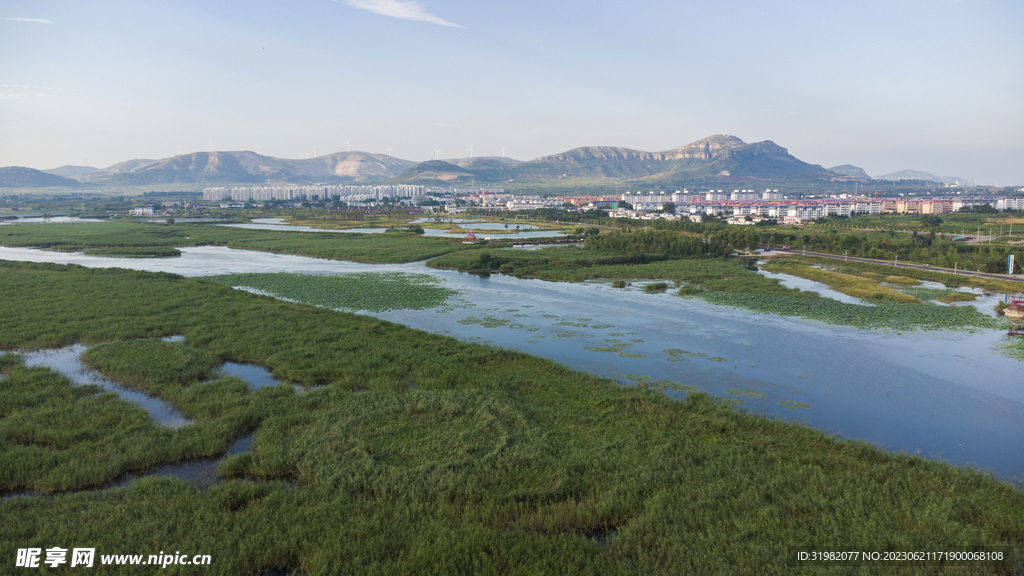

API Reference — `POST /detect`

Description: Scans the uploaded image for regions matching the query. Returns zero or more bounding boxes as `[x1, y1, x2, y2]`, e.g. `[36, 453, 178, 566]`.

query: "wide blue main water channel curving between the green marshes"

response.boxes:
[0, 242, 1024, 480]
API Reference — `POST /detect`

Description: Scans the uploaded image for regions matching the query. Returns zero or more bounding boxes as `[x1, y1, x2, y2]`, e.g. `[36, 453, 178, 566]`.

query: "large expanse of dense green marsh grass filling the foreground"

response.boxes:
[0, 259, 1024, 574]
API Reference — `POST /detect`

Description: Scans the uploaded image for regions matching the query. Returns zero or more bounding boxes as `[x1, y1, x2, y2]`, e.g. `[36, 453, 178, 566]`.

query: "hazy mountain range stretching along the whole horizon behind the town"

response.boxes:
[0, 135, 966, 188]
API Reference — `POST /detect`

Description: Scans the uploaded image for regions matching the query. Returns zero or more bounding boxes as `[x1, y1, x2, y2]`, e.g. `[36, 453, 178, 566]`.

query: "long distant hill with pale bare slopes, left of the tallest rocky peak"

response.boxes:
[80, 151, 416, 186]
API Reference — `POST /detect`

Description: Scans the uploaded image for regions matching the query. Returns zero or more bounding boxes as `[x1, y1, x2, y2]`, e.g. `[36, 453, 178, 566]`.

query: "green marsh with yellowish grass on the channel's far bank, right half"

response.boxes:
[428, 231, 1020, 330]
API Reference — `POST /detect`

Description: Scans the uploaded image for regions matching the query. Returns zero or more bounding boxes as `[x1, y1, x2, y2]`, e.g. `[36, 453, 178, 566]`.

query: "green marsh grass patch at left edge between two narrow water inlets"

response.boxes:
[0, 354, 269, 493]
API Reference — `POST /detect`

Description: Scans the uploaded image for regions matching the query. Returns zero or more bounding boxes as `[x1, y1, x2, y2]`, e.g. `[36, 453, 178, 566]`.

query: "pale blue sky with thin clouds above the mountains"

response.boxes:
[0, 0, 1024, 186]
